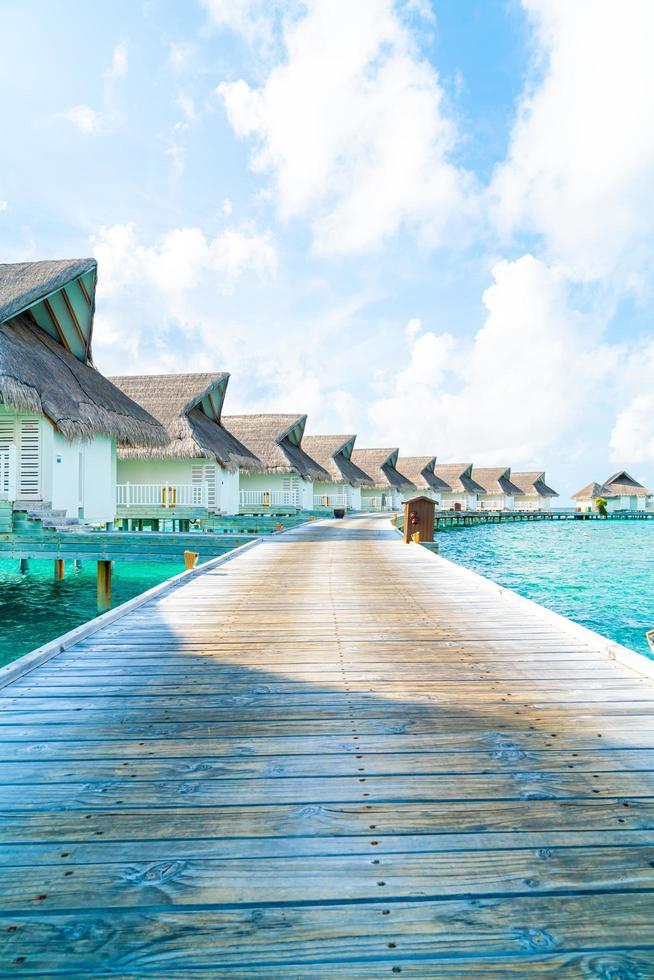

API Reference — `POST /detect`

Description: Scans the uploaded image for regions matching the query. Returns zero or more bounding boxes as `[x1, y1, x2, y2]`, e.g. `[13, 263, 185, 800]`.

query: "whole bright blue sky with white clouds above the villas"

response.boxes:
[0, 0, 654, 498]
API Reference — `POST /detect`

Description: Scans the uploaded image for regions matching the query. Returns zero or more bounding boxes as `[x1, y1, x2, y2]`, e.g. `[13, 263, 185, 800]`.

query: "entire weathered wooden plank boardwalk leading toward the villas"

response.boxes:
[0, 517, 654, 980]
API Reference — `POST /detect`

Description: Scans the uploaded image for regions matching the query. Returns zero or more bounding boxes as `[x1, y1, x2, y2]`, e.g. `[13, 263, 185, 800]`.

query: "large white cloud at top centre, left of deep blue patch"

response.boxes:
[218, 0, 468, 253]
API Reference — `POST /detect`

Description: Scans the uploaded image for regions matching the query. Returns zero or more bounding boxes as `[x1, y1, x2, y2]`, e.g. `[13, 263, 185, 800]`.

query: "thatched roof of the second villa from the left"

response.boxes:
[110, 372, 262, 472]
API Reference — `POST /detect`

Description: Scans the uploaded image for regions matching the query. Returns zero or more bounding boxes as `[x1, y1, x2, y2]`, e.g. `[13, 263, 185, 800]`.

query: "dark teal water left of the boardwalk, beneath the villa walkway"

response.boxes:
[0, 560, 184, 667]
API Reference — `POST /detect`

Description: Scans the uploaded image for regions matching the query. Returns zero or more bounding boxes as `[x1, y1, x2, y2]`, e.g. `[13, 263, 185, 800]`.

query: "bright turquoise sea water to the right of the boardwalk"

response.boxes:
[436, 521, 654, 654]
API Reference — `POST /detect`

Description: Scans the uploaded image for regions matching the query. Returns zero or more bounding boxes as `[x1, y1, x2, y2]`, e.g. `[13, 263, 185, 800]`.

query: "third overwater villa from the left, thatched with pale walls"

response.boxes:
[223, 415, 331, 514]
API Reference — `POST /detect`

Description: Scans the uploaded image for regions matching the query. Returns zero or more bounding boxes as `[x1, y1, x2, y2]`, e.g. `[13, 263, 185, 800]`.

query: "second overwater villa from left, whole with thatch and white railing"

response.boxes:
[111, 373, 262, 520]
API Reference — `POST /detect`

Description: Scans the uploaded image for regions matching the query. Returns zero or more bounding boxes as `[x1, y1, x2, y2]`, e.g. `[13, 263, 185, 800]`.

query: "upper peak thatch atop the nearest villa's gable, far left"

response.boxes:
[0, 259, 96, 323]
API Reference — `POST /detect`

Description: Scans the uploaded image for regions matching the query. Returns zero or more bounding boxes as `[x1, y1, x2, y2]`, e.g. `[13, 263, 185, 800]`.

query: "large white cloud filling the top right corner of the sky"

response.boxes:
[492, 0, 654, 288]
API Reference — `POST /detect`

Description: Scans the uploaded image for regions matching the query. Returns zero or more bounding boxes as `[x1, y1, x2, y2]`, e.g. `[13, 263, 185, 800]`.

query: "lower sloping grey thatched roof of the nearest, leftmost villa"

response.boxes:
[0, 316, 168, 446]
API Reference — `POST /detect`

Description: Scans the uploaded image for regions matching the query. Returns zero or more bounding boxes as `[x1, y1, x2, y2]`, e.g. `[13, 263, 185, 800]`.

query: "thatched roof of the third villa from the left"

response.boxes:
[223, 415, 330, 483]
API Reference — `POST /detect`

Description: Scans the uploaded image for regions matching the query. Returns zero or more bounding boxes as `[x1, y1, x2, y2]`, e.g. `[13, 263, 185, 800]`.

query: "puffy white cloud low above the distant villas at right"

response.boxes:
[369, 255, 616, 466]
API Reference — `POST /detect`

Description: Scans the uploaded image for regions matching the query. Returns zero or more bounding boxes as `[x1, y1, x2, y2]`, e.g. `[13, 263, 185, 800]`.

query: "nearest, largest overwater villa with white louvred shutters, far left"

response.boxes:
[0, 259, 168, 524]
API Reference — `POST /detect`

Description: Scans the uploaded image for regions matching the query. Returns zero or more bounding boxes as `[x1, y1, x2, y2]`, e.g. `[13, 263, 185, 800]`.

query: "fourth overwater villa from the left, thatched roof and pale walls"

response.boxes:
[302, 435, 374, 510]
